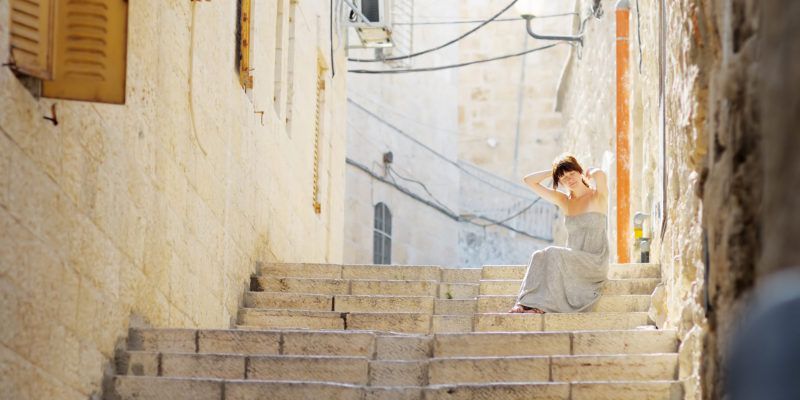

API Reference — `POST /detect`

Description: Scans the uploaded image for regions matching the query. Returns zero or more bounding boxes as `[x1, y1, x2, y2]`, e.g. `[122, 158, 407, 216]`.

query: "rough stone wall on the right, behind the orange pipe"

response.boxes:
[559, 0, 800, 399]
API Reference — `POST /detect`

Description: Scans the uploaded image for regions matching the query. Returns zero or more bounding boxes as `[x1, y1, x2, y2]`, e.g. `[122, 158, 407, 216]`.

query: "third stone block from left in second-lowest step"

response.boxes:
[247, 356, 369, 385]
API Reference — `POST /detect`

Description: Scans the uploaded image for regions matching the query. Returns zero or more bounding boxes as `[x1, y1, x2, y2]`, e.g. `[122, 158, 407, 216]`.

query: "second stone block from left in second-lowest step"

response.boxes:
[161, 353, 245, 379]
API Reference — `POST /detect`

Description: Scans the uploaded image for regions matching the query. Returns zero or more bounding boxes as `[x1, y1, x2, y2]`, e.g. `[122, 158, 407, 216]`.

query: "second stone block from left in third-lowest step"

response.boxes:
[197, 330, 281, 354]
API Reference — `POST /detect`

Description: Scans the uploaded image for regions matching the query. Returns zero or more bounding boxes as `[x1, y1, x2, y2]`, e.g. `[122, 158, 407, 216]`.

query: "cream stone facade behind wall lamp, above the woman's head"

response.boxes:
[458, 0, 575, 182]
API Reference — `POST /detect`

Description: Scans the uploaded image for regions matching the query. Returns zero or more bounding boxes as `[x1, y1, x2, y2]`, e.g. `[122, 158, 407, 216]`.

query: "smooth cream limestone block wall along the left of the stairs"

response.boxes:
[0, 0, 346, 399]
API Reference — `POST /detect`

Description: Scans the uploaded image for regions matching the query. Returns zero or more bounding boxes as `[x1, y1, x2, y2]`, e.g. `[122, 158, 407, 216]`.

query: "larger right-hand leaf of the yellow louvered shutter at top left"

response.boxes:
[42, 0, 128, 104]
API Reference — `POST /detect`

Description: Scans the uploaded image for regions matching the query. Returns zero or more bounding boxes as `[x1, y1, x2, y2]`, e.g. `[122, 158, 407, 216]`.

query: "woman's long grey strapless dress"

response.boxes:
[517, 212, 609, 312]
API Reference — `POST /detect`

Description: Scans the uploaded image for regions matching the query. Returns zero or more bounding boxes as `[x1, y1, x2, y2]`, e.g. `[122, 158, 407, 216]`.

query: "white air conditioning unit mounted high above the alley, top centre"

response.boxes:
[348, 0, 393, 48]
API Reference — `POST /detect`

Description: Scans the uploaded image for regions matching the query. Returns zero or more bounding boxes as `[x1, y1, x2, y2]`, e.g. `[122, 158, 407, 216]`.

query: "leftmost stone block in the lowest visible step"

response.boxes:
[113, 376, 222, 400]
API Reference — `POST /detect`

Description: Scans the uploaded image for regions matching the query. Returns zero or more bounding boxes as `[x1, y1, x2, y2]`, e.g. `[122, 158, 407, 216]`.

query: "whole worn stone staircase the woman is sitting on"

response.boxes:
[109, 264, 682, 400]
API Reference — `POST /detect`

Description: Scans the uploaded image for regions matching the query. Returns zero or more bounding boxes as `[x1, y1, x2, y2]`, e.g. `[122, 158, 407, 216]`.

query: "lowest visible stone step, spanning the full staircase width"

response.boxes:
[112, 376, 682, 400]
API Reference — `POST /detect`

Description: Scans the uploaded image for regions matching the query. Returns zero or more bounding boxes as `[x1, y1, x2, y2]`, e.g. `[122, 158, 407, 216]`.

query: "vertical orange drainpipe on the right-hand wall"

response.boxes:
[616, 0, 631, 263]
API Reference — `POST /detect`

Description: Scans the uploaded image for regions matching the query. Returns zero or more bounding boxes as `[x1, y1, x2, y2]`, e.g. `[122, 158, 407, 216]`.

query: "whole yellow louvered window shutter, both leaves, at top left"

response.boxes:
[11, 0, 128, 104]
